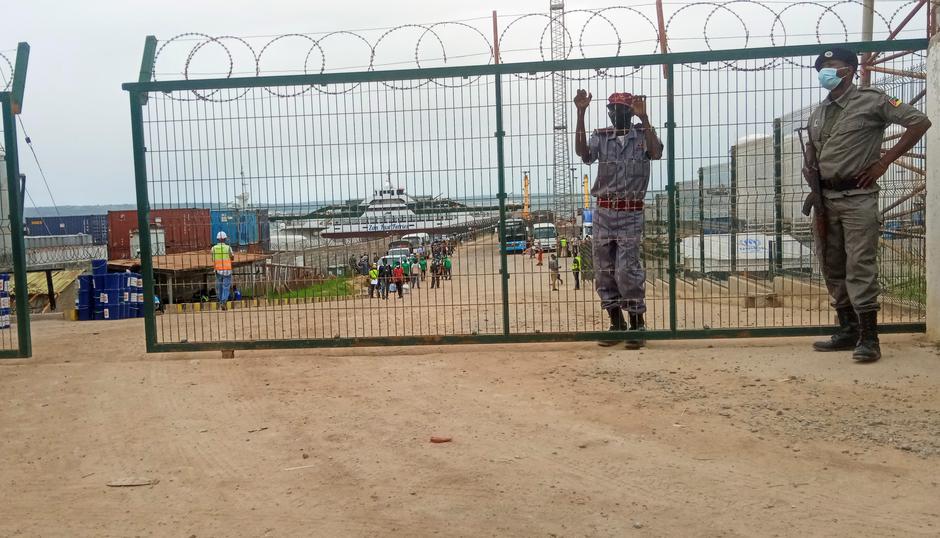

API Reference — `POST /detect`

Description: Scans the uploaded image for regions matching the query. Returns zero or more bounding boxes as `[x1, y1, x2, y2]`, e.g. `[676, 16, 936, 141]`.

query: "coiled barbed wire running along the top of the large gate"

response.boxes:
[151, 0, 918, 102]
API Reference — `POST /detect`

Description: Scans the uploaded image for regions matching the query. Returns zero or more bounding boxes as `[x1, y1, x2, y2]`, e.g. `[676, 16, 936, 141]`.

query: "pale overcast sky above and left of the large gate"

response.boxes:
[0, 0, 922, 206]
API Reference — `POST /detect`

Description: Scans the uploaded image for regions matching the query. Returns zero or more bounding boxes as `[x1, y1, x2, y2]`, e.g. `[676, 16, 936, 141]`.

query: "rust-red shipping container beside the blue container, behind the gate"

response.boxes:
[108, 209, 212, 260]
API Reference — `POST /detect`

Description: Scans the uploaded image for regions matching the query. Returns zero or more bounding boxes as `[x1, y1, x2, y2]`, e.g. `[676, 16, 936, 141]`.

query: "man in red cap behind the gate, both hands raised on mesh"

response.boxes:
[575, 90, 663, 348]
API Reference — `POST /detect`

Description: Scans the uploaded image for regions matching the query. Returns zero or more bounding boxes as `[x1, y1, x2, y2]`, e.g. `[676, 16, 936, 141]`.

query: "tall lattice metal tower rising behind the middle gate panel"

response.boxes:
[549, 0, 574, 221]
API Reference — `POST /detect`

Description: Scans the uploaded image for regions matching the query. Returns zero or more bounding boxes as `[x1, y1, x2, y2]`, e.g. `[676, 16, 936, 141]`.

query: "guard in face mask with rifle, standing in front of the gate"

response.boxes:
[804, 49, 930, 361]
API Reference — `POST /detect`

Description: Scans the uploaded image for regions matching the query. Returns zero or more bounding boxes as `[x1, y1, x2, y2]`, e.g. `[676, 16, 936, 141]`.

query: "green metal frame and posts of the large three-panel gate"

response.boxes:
[122, 36, 928, 352]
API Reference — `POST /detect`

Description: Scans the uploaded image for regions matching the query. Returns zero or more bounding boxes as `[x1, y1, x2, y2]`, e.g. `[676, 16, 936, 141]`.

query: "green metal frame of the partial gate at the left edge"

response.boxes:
[0, 43, 33, 359]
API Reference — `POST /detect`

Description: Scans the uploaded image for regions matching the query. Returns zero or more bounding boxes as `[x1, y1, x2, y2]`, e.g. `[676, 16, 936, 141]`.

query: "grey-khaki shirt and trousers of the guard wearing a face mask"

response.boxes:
[808, 85, 927, 313]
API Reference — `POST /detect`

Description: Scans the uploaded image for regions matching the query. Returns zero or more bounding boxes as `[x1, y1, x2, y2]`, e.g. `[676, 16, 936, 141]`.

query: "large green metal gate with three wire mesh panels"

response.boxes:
[123, 38, 927, 351]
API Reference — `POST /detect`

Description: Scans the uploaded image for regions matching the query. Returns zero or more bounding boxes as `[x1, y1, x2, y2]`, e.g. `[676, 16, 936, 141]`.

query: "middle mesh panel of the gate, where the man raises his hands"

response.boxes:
[503, 65, 669, 332]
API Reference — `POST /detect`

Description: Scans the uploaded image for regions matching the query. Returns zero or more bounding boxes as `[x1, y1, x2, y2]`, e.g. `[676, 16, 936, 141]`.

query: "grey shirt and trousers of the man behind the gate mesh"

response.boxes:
[588, 125, 662, 314]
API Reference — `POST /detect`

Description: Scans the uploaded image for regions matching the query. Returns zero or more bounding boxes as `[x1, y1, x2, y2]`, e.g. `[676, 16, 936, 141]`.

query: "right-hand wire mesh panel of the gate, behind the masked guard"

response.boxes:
[675, 48, 925, 329]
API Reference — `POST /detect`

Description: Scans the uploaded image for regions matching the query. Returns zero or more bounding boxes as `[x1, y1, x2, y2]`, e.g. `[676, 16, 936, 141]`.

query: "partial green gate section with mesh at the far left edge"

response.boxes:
[0, 43, 32, 358]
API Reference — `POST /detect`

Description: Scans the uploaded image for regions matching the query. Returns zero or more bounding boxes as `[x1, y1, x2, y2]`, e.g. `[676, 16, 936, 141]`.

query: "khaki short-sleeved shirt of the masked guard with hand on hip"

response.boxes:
[808, 85, 927, 198]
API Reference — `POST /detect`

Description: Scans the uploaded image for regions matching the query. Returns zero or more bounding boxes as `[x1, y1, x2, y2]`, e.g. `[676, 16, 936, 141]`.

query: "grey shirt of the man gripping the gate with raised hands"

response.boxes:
[588, 125, 662, 200]
